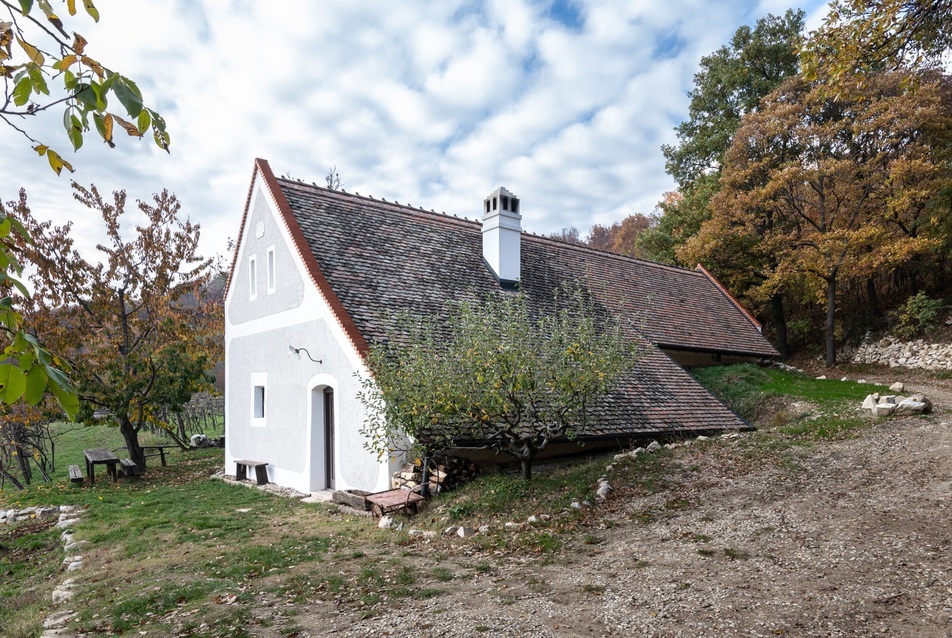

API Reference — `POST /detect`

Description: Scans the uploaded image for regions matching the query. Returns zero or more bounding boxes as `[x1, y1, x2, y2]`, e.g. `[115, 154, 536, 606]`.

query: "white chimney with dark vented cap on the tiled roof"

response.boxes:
[483, 186, 522, 285]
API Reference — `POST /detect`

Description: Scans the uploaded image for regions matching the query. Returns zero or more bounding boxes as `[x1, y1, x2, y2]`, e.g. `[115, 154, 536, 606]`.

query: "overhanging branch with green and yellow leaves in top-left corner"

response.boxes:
[0, 0, 169, 175]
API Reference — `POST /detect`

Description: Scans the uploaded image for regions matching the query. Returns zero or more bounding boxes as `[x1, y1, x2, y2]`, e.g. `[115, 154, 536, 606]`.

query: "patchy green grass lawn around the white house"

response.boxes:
[0, 366, 900, 638]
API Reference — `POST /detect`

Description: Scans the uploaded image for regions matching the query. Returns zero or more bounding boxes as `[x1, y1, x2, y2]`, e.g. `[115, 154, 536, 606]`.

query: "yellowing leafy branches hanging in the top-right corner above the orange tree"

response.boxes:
[803, 0, 952, 80]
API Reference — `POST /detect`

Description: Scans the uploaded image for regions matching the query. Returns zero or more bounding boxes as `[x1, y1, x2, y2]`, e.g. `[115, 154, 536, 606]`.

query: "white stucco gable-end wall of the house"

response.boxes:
[225, 175, 393, 492]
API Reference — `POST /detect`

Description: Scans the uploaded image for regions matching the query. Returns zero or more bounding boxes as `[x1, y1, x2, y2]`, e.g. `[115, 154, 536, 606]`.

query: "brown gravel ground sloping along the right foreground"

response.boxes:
[296, 382, 952, 638]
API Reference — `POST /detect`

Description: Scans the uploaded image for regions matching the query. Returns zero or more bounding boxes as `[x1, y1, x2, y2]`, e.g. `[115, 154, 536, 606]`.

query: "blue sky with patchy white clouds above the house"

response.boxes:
[0, 0, 826, 262]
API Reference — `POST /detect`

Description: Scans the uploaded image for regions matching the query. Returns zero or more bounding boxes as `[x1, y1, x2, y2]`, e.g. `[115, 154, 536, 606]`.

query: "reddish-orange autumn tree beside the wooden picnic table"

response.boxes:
[13, 183, 222, 469]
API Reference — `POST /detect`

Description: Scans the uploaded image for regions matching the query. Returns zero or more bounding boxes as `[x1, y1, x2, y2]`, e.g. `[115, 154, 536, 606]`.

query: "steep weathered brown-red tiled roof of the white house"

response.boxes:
[259, 164, 776, 436]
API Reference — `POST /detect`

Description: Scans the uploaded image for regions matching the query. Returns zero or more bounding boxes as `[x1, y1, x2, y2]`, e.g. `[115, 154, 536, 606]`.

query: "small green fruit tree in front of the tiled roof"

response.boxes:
[359, 291, 636, 480]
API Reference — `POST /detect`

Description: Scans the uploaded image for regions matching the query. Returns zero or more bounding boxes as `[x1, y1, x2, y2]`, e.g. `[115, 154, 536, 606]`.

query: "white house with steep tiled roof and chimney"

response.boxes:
[225, 160, 777, 492]
